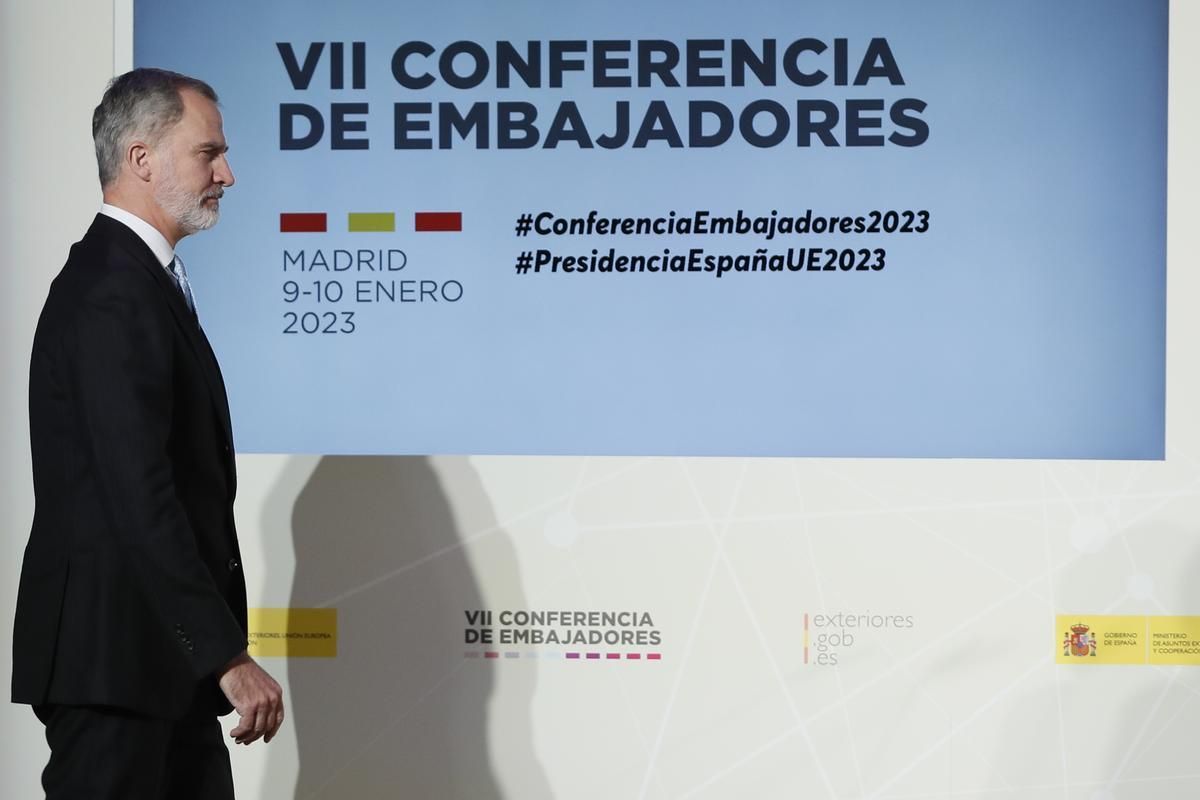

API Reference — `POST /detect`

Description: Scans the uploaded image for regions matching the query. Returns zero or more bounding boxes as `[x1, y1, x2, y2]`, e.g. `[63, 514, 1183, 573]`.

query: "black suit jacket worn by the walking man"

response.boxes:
[12, 216, 246, 718]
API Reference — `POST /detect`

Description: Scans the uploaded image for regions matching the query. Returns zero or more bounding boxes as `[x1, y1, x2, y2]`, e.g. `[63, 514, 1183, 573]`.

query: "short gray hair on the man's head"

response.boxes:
[91, 67, 217, 187]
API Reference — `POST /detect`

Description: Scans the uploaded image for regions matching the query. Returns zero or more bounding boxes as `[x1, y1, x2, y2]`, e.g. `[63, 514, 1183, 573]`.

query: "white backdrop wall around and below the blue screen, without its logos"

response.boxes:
[0, 0, 1200, 800]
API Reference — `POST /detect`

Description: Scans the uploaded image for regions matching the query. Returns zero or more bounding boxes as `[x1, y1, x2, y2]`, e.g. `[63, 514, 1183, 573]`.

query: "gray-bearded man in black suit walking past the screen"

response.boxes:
[12, 70, 283, 800]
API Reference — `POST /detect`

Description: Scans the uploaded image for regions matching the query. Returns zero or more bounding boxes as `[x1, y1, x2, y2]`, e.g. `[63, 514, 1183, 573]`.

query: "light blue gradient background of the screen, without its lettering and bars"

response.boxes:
[134, 0, 1168, 459]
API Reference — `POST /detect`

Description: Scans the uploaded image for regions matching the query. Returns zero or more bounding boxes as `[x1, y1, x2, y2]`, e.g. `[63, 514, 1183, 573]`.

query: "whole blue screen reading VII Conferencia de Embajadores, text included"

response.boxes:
[134, 0, 1168, 459]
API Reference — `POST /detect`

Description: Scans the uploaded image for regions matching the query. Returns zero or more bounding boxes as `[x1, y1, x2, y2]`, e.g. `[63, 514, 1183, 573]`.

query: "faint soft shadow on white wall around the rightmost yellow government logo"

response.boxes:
[988, 523, 1200, 800]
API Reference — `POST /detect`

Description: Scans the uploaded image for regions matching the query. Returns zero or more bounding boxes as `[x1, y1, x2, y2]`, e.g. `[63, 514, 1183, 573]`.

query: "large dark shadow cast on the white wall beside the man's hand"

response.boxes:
[263, 456, 551, 800]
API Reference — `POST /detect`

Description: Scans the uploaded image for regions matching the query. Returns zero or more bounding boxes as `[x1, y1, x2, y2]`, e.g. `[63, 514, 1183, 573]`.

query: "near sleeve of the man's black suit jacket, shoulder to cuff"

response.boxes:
[67, 276, 246, 679]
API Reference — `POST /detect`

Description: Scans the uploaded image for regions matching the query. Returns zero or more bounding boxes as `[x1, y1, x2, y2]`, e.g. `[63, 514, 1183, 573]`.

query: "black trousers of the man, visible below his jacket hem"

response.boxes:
[34, 705, 233, 800]
